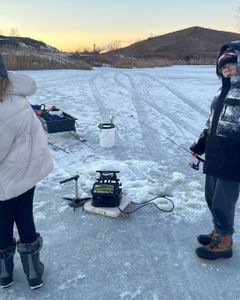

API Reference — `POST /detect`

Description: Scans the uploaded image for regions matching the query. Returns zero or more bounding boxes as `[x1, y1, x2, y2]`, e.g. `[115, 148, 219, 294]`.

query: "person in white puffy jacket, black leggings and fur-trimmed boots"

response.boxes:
[0, 54, 53, 289]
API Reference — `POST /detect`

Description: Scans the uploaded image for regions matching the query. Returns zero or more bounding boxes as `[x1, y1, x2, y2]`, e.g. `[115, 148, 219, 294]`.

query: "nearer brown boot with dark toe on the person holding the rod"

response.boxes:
[196, 231, 232, 260]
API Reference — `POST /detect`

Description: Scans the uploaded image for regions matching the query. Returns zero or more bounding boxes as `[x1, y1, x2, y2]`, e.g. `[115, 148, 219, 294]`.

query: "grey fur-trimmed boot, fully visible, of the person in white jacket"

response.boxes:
[17, 233, 44, 290]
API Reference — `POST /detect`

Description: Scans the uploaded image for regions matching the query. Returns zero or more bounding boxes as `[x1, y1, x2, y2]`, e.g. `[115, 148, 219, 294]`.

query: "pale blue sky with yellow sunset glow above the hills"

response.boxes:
[0, 0, 240, 51]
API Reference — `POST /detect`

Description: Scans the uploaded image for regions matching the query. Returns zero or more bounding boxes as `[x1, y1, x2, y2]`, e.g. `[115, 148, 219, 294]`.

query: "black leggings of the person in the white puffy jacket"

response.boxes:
[0, 187, 37, 249]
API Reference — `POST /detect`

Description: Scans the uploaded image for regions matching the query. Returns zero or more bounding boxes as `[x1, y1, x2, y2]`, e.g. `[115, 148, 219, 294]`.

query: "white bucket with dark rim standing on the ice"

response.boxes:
[99, 123, 116, 148]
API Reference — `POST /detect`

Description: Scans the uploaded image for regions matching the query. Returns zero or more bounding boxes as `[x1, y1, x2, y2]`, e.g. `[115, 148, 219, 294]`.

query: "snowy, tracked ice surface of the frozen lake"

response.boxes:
[0, 66, 240, 300]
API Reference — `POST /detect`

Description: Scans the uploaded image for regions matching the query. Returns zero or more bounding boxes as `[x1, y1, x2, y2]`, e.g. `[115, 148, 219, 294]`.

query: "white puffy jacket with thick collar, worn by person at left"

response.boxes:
[0, 72, 53, 201]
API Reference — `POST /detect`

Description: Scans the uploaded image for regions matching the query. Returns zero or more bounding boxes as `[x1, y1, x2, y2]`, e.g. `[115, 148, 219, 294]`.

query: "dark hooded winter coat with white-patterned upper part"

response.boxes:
[190, 41, 240, 182]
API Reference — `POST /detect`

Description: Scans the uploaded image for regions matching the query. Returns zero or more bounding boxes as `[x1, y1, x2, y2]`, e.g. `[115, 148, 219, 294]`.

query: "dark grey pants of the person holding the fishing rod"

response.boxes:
[205, 175, 240, 235]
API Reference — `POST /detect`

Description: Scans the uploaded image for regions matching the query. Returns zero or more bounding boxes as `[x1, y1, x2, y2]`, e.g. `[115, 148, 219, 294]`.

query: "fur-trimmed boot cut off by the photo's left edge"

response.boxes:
[0, 239, 16, 288]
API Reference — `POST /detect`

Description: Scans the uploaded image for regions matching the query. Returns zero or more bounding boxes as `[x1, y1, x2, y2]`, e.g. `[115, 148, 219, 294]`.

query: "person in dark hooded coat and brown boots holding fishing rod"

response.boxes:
[190, 41, 240, 260]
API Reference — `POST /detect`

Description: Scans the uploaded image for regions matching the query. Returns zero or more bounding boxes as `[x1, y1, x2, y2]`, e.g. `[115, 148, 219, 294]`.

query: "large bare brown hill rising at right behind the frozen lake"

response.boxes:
[108, 26, 240, 64]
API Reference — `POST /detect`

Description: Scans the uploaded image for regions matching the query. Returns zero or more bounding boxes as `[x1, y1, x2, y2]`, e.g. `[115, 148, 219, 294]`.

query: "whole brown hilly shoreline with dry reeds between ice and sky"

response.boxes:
[0, 26, 240, 70]
